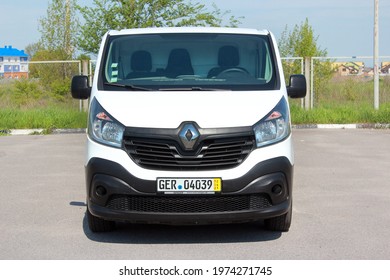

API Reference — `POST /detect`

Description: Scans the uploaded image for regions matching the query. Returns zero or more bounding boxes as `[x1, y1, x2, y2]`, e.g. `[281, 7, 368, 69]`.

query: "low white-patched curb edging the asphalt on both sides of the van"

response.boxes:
[0, 123, 390, 136]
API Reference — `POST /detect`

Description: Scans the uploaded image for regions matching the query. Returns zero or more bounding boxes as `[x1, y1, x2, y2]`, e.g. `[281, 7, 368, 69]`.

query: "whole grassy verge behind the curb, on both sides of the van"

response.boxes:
[0, 77, 390, 135]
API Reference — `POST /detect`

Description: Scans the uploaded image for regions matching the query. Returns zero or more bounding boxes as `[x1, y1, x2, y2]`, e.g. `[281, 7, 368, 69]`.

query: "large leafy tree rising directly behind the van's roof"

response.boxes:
[78, 0, 241, 53]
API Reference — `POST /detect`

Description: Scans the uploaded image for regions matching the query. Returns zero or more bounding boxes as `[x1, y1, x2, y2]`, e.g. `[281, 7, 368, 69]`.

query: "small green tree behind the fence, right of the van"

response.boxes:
[278, 18, 333, 106]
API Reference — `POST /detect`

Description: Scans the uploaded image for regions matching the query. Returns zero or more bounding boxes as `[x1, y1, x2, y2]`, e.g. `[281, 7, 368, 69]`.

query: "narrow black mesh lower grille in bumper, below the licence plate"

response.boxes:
[107, 194, 272, 213]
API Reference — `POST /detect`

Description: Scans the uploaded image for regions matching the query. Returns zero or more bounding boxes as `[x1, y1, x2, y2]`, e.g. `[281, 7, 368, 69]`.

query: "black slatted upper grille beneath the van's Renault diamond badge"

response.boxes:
[124, 136, 254, 170]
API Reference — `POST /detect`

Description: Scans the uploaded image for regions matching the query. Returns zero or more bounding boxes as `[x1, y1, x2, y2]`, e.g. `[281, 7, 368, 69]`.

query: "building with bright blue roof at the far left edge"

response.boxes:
[0, 46, 28, 79]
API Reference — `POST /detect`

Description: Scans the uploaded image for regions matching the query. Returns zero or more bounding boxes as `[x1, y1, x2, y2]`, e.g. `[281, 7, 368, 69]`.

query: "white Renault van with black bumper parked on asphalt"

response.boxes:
[72, 27, 306, 232]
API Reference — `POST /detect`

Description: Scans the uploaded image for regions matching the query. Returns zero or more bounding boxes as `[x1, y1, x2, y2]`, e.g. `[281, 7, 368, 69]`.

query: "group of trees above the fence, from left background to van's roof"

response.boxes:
[26, 0, 242, 60]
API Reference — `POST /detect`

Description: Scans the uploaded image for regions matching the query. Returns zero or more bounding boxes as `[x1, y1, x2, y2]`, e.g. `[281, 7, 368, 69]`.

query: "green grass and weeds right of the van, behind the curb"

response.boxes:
[290, 76, 390, 124]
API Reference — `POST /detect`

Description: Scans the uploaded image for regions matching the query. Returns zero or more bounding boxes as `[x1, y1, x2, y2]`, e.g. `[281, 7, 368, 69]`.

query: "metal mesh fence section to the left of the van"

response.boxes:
[0, 60, 82, 107]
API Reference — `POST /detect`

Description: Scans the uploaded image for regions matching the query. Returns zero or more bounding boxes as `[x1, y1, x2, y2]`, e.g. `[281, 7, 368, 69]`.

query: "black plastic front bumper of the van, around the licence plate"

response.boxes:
[86, 157, 293, 224]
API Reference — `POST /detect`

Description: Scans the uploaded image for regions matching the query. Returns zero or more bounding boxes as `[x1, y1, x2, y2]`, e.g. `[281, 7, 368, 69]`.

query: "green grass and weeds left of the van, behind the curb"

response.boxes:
[0, 80, 87, 131]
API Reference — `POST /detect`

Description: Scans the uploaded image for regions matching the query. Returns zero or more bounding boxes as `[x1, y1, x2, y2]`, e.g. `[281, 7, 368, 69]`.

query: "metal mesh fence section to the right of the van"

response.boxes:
[282, 56, 390, 109]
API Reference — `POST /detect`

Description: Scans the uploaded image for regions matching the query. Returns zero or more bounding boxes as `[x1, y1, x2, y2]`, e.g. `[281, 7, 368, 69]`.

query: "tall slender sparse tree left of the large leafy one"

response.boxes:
[39, 0, 79, 59]
